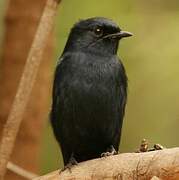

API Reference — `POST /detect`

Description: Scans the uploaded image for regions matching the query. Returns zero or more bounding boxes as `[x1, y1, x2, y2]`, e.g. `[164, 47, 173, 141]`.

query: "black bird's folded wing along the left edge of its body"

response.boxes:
[50, 53, 79, 164]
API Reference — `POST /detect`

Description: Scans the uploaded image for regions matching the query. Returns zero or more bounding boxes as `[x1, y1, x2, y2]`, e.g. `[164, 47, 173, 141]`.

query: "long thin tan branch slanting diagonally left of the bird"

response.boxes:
[0, 0, 60, 179]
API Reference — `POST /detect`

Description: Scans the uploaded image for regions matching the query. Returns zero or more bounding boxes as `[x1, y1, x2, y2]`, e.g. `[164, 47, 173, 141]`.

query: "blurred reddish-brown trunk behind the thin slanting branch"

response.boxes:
[0, 0, 53, 180]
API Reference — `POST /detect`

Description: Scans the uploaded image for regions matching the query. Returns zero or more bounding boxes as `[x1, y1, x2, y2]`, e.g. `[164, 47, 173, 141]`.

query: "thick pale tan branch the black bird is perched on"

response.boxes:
[34, 148, 179, 180]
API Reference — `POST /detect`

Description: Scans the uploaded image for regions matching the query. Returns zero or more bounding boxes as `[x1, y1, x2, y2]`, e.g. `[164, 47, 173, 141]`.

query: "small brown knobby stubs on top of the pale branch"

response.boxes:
[135, 139, 164, 153]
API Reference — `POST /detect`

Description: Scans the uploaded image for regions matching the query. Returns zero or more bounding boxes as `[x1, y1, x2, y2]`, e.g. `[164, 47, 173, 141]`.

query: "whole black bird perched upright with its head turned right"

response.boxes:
[51, 17, 132, 166]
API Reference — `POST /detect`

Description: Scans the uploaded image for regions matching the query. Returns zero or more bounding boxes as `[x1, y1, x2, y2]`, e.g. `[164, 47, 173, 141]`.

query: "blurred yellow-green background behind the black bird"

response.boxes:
[0, 0, 179, 173]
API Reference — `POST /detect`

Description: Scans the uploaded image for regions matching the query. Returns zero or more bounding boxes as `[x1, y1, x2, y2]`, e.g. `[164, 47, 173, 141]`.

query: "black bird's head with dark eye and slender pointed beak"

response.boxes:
[64, 17, 132, 54]
